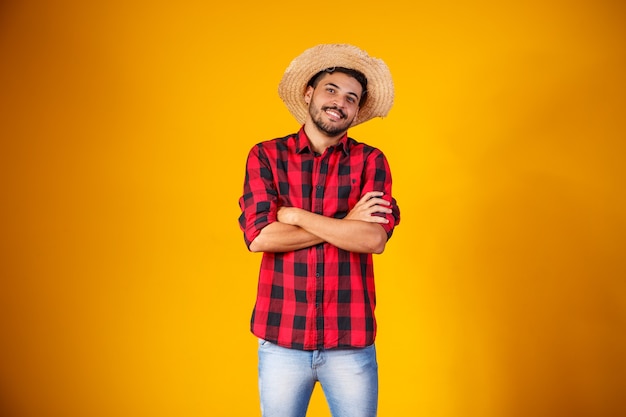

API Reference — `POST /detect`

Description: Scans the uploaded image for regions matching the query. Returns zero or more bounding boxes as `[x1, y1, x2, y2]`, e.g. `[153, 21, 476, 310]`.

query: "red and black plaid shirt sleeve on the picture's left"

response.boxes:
[239, 144, 278, 249]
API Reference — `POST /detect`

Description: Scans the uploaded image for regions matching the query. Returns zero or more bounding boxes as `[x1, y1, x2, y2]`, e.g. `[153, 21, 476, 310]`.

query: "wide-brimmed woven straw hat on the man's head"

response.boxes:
[278, 44, 394, 126]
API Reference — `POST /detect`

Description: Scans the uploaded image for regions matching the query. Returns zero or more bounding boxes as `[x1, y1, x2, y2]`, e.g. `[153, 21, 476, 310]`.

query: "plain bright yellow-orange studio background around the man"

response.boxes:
[0, 0, 626, 417]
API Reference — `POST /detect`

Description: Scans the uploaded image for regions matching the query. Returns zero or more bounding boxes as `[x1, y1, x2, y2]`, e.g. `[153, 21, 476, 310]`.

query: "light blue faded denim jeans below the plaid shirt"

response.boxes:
[259, 340, 378, 417]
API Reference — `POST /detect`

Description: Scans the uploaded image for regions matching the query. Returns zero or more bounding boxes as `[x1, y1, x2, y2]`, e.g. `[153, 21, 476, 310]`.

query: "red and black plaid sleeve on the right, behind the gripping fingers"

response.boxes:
[362, 149, 400, 239]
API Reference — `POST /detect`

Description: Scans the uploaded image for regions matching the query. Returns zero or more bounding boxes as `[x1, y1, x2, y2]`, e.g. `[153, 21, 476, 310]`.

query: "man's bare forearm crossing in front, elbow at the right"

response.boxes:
[288, 210, 387, 253]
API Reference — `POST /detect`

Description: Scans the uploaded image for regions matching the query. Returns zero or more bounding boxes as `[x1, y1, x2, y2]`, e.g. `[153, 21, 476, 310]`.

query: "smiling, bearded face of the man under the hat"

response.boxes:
[304, 72, 363, 136]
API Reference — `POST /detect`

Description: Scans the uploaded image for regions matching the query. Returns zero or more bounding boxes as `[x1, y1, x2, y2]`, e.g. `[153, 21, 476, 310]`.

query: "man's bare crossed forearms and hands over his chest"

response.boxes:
[250, 191, 391, 253]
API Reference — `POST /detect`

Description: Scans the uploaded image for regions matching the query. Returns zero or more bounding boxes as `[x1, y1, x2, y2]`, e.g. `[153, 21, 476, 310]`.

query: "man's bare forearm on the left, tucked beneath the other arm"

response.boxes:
[250, 222, 324, 252]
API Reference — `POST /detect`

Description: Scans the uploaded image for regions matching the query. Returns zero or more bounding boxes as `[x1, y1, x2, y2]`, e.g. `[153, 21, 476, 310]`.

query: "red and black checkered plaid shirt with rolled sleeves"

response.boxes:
[239, 129, 400, 350]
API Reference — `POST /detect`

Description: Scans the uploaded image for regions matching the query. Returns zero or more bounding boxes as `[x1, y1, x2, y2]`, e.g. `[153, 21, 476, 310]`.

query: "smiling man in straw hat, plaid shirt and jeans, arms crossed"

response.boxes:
[239, 44, 400, 417]
